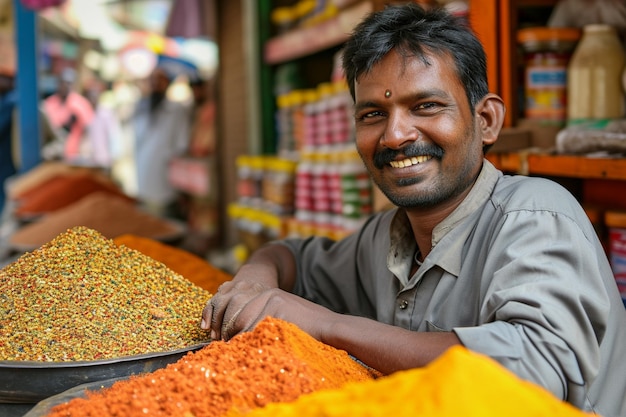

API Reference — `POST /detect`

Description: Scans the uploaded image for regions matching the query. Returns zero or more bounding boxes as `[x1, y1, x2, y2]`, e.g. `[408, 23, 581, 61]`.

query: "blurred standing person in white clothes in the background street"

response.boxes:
[132, 58, 191, 217]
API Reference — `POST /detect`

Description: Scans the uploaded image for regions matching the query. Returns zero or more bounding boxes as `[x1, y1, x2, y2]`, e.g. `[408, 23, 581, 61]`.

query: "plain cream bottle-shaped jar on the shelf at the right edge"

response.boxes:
[567, 24, 626, 123]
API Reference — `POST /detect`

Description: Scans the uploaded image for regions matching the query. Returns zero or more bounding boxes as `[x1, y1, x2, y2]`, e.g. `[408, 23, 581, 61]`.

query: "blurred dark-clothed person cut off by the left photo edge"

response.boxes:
[0, 74, 17, 213]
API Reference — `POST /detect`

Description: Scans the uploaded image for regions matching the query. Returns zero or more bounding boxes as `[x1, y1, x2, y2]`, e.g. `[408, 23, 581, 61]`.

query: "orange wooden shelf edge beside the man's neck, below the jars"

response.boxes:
[487, 151, 626, 181]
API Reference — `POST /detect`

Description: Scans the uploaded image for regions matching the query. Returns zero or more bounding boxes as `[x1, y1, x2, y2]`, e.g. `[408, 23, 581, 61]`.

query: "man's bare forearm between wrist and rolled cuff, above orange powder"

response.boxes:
[322, 315, 460, 374]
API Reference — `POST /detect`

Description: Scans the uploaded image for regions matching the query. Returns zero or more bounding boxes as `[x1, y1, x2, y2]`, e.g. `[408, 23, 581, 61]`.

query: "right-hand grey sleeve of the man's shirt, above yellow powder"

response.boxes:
[454, 206, 609, 398]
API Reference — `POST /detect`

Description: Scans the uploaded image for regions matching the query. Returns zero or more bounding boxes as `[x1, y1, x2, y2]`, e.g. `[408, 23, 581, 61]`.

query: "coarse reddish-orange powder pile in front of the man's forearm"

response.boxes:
[48, 318, 379, 417]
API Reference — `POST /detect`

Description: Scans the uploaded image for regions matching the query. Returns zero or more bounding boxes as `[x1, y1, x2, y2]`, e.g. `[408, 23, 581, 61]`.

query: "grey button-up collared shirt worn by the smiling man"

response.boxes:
[282, 161, 626, 417]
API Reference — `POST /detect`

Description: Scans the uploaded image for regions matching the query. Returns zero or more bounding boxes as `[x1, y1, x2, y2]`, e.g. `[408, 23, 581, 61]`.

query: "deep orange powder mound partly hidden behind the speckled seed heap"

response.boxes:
[113, 234, 232, 294]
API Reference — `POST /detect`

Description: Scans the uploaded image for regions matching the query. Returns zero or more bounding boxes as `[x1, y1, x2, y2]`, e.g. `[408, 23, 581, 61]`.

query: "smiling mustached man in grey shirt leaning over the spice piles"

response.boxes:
[201, 4, 626, 416]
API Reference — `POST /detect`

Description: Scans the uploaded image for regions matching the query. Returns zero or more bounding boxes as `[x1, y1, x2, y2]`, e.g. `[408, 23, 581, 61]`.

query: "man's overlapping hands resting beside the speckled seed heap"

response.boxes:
[201, 281, 335, 340]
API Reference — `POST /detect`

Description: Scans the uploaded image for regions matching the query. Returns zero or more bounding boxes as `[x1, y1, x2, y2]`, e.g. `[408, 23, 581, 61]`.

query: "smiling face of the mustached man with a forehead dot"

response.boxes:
[355, 51, 483, 208]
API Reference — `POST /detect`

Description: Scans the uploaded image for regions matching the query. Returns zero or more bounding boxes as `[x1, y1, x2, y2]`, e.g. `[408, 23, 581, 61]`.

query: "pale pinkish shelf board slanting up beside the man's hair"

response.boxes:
[263, 1, 375, 65]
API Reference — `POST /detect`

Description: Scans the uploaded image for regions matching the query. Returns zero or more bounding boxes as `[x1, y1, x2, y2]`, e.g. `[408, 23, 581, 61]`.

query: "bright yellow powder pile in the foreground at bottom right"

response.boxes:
[227, 346, 591, 417]
